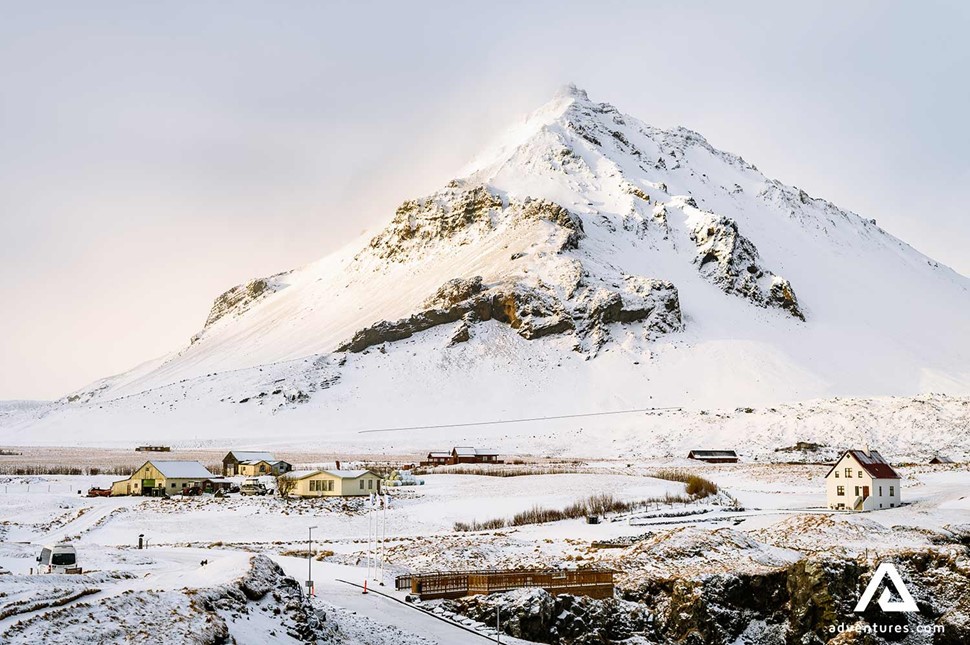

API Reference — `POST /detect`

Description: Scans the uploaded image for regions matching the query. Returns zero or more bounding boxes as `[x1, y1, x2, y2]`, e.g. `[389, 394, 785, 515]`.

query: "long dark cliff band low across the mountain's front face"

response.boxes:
[337, 276, 682, 352]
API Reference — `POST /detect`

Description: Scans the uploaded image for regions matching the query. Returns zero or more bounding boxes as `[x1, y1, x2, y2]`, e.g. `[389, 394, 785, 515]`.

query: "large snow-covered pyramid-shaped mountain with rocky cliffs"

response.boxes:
[0, 86, 970, 452]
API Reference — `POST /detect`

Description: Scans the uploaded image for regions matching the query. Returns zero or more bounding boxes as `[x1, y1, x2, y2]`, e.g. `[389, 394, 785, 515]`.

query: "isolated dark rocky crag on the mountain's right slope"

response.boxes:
[687, 213, 805, 320]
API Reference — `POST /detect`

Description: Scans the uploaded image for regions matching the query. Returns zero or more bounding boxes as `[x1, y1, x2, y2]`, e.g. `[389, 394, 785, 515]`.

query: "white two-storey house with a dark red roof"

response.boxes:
[825, 450, 902, 511]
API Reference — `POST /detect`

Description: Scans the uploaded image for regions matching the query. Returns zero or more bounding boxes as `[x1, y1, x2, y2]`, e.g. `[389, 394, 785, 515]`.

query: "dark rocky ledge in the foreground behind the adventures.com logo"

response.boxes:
[445, 544, 970, 645]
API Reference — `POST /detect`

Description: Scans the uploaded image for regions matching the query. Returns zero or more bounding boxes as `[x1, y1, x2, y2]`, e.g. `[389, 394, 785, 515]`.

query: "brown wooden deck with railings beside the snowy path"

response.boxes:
[395, 569, 614, 600]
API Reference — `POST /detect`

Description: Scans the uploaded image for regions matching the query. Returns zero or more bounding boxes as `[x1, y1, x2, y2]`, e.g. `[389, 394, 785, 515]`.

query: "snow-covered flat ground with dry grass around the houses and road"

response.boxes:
[0, 462, 970, 644]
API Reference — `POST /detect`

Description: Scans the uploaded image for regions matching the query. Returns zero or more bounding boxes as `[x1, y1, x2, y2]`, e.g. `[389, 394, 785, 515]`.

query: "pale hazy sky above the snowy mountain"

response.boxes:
[0, 1, 970, 399]
